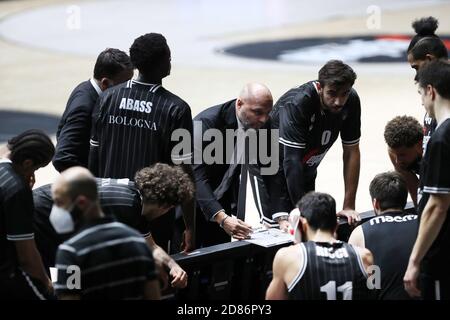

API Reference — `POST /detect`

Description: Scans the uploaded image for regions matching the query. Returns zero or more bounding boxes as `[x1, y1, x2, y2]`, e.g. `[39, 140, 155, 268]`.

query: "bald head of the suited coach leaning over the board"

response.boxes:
[236, 82, 273, 129]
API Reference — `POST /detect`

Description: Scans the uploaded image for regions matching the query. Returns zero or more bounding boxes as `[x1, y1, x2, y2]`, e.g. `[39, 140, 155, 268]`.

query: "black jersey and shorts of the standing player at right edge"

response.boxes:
[419, 119, 450, 279]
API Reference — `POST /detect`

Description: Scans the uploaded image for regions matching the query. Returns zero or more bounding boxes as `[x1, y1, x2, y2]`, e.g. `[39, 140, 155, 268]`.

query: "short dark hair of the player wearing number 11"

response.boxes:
[297, 191, 337, 231]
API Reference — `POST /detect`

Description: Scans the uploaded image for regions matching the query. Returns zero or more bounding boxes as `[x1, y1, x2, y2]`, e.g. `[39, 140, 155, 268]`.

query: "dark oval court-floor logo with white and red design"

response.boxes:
[223, 34, 450, 64]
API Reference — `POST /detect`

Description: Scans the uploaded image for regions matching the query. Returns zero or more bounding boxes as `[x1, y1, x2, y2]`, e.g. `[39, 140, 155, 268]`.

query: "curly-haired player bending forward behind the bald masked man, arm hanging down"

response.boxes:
[33, 163, 194, 288]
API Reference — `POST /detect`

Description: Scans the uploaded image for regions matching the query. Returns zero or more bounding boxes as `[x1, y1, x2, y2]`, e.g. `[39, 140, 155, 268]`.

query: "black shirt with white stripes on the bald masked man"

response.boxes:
[54, 217, 156, 299]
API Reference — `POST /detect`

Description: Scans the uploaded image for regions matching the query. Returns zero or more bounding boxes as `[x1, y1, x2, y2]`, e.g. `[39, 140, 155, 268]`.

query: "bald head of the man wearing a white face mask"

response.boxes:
[53, 167, 98, 201]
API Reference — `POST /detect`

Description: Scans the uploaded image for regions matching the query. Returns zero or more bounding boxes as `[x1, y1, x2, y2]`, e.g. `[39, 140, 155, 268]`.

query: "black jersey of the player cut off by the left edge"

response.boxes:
[0, 160, 34, 273]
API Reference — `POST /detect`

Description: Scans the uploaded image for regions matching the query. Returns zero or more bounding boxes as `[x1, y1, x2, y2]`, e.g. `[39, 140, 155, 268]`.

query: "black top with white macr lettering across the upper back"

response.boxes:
[361, 211, 419, 300]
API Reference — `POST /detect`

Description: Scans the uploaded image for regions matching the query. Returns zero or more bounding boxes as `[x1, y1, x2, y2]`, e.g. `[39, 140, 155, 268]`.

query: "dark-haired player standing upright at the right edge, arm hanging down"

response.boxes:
[403, 60, 450, 300]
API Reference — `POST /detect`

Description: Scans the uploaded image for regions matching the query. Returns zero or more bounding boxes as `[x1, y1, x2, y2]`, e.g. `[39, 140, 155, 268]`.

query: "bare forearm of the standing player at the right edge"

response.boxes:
[409, 195, 449, 264]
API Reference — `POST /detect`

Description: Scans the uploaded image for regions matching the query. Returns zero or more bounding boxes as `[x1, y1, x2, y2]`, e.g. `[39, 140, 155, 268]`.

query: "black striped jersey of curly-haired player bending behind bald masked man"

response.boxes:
[33, 178, 150, 266]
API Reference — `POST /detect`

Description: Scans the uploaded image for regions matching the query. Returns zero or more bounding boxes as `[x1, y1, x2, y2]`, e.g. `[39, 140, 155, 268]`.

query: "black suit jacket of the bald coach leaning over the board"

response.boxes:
[193, 99, 291, 224]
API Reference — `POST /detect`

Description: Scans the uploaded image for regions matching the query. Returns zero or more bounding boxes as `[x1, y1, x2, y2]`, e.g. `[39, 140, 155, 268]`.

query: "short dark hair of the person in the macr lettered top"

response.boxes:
[369, 171, 408, 211]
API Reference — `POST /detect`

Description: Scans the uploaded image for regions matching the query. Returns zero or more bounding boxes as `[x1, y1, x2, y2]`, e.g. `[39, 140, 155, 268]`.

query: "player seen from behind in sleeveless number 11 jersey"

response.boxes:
[266, 192, 373, 300]
